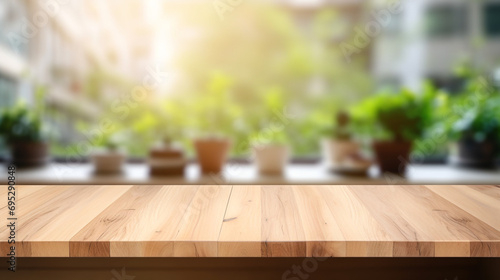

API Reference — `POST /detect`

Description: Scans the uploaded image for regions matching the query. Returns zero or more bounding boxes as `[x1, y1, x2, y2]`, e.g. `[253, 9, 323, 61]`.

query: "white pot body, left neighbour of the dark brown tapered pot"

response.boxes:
[321, 139, 360, 167]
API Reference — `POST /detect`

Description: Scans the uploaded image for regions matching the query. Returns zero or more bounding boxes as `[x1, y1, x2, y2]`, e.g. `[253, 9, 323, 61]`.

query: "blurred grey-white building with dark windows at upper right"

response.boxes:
[372, 0, 500, 91]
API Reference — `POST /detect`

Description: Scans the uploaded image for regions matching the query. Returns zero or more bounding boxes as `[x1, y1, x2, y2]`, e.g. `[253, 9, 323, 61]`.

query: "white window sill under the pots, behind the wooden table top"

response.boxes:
[0, 163, 500, 185]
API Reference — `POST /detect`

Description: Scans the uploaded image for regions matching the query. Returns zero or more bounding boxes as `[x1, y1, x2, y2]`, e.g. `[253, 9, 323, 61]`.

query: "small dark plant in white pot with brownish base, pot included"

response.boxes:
[321, 111, 371, 174]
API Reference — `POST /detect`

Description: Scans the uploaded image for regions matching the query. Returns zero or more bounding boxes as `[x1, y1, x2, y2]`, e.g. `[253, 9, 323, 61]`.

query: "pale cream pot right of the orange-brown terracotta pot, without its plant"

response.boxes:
[253, 144, 289, 175]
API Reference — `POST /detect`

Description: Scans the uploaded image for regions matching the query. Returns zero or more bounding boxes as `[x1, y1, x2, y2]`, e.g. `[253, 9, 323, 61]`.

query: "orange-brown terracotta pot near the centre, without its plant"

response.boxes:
[194, 139, 231, 174]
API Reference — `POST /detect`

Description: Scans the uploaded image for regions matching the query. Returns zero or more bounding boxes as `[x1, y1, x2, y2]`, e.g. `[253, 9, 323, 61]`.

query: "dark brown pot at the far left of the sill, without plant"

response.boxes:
[10, 142, 49, 167]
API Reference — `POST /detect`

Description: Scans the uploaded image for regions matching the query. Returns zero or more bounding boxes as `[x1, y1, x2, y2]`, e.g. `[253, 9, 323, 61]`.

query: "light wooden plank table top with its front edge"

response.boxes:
[0, 185, 500, 257]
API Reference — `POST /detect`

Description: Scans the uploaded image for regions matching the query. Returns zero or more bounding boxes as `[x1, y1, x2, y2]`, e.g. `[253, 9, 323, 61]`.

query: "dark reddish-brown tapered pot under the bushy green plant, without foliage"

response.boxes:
[373, 141, 412, 176]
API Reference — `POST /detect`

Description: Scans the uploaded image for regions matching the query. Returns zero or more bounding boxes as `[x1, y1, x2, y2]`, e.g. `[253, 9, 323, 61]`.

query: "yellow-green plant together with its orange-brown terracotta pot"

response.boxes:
[192, 74, 241, 174]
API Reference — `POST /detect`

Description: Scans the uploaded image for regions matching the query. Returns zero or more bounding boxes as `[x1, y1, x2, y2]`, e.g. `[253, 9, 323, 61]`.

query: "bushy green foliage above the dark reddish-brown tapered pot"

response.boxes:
[351, 85, 436, 141]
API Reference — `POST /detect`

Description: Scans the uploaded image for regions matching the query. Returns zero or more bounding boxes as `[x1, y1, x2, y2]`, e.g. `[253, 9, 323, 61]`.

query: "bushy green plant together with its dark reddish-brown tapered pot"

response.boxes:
[351, 85, 435, 175]
